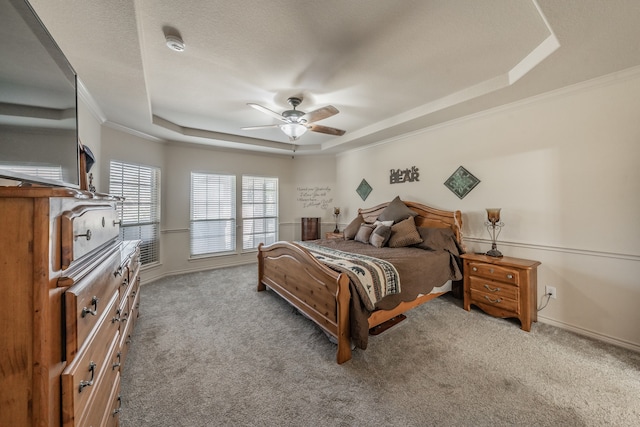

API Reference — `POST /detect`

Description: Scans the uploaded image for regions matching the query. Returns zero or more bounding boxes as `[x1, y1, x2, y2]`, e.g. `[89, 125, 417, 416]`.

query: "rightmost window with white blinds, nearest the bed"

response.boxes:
[242, 176, 278, 250]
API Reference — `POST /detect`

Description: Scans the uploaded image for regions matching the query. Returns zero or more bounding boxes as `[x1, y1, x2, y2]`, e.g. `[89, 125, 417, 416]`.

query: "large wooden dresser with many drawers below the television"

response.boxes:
[0, 187, 140, 427]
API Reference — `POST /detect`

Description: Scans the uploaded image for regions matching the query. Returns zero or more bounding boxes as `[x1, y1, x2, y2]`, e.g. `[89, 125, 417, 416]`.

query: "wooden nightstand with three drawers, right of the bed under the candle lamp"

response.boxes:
[461, 253, 540, 332]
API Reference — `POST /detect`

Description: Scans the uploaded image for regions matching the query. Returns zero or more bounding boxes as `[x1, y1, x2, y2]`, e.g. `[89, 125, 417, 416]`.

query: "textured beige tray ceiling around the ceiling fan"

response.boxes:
[18, 0, 640, 153]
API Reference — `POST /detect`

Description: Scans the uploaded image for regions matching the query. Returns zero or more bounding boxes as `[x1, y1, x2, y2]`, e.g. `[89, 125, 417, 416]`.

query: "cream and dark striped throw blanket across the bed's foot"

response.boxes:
[296, 241, 400, 311]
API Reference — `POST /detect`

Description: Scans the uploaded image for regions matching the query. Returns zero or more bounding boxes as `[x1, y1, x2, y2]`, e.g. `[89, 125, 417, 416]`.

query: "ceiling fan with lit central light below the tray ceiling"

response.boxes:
[242, 97, 345, 142]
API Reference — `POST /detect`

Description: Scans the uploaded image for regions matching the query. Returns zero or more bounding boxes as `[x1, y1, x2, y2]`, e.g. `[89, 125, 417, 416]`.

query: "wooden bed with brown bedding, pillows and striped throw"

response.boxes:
[258, 197, 464, 364]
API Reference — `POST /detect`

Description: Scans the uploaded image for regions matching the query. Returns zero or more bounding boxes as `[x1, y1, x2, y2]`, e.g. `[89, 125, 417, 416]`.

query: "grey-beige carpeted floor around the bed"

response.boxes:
[120, 265, 640, 427]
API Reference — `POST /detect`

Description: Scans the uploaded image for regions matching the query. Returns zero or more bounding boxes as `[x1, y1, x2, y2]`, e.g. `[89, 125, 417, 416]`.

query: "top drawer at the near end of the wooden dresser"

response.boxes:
[60, 204, 120, 269]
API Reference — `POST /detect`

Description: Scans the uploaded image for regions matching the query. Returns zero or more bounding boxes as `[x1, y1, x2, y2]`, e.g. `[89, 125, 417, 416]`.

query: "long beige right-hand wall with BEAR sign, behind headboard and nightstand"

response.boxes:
[337, 72, 640, 349]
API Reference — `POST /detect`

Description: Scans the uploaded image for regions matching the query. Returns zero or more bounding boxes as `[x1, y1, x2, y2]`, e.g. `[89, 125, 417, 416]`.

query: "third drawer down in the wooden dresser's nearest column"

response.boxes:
[61, 304, 119, 426]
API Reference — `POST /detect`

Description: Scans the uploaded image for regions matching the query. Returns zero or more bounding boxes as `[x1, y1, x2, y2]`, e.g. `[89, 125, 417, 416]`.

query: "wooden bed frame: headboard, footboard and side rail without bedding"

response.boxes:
[258, 201, 462, 364]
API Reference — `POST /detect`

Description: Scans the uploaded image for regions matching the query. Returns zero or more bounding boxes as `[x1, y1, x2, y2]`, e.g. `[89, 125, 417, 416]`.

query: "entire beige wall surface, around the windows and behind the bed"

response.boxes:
[92, 69, 640, 349]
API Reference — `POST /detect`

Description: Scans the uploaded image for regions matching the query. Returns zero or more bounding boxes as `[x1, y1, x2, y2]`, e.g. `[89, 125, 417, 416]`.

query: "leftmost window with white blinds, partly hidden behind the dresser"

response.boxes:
[109, 161, 160, 265]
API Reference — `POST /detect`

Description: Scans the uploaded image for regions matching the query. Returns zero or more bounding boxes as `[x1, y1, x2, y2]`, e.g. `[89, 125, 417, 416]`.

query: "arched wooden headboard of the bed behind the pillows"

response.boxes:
[358, 200, 463, 246]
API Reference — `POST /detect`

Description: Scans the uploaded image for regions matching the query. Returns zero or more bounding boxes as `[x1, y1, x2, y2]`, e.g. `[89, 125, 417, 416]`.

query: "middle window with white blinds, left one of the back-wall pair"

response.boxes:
[194, 172, 236, 256]
